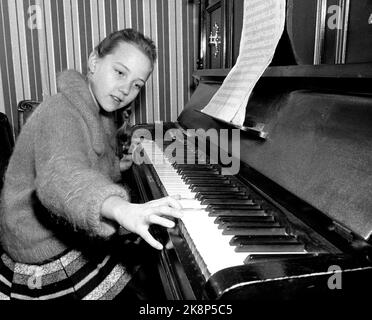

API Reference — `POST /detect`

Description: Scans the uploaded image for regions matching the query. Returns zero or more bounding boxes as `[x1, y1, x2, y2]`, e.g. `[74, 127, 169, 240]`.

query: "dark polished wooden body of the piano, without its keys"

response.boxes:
[128, 0, 372, 300]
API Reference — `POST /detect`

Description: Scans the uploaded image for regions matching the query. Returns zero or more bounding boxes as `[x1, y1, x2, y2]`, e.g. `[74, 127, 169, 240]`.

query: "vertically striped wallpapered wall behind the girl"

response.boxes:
[0, 0, 199, 136]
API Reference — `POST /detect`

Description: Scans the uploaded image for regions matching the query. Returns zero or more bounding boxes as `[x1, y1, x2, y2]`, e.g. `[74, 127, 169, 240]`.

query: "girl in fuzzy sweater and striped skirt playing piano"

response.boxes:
[0, 29, 181, 299]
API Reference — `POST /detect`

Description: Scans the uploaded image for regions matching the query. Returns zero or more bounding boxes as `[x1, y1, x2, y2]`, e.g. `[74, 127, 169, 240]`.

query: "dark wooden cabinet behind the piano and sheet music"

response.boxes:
[198, 0, 372, 70]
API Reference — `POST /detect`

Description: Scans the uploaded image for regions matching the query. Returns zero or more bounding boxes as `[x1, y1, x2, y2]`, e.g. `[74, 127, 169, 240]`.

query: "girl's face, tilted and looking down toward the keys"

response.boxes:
[89, 42, 152, 112]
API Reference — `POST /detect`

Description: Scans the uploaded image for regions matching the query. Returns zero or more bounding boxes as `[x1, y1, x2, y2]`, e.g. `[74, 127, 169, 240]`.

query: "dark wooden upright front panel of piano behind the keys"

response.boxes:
[178, 82, 372, 239]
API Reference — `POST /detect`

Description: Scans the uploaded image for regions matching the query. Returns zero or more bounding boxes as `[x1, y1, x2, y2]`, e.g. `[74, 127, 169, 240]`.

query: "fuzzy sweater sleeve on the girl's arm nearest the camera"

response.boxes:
[34, 101, 129, 237]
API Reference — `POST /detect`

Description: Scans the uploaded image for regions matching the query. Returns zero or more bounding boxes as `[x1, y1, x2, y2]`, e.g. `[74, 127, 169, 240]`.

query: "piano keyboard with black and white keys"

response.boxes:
[141, 140, 308, 279]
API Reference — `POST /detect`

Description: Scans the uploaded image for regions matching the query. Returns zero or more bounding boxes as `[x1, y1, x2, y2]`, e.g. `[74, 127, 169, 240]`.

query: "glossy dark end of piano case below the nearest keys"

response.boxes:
[205, 255, 372, 301]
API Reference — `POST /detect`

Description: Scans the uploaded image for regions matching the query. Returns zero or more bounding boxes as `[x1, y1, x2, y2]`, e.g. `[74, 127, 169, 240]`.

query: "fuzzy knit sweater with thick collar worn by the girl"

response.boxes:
[0, 70, 129, 264]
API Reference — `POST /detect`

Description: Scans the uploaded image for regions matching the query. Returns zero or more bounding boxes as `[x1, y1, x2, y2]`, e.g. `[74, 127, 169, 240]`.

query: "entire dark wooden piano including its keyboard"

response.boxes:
[125, 1, 372, 301]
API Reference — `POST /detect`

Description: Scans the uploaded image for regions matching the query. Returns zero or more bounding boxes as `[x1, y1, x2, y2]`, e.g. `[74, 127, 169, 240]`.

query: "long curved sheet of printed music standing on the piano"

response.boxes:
[202, 0, 286, 126]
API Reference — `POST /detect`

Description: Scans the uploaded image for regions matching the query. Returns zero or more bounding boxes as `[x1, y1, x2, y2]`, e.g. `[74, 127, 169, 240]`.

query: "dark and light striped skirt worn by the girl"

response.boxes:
[0, 246, 131, 300]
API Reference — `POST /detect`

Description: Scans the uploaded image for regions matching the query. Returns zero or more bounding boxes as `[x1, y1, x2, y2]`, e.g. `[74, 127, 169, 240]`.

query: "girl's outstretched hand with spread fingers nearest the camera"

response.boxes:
[103, 197, 182, 250]
